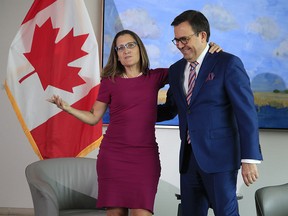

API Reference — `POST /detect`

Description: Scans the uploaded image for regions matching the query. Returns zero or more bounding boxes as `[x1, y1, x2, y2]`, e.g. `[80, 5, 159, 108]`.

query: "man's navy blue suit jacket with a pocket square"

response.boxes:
[158, 52, 262, 173]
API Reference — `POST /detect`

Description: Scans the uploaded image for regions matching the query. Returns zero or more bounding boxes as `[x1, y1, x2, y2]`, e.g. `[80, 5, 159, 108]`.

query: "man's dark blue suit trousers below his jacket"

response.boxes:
[180, 146, 239, 216]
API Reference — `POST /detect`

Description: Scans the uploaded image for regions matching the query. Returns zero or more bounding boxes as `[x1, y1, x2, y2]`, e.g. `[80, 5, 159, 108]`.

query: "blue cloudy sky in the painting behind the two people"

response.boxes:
[104, 0, 288, 89]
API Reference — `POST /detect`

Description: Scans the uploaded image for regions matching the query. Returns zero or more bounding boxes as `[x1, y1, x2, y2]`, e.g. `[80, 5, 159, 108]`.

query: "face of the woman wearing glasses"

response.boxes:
[116, 34, 140, 70]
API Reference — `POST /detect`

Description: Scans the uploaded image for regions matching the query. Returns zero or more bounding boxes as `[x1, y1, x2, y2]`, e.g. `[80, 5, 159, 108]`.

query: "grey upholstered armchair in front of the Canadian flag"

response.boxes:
[25, 158, 106, 216]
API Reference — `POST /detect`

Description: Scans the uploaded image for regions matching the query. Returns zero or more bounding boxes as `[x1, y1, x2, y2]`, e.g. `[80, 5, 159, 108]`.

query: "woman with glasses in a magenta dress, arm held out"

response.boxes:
[49, 30, 219, 216]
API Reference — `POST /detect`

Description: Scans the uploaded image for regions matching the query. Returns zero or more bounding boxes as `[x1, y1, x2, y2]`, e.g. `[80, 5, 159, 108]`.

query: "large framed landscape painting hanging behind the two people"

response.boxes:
[102, 0, 288, 129]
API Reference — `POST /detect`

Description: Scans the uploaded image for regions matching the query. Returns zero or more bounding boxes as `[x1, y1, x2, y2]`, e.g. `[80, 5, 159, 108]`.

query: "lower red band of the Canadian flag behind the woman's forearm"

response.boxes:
[31, 85, 102, 159]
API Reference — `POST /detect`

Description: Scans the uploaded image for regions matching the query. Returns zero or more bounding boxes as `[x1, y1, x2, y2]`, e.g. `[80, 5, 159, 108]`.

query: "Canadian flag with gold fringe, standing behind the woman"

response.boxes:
[5, 0, 102, 159]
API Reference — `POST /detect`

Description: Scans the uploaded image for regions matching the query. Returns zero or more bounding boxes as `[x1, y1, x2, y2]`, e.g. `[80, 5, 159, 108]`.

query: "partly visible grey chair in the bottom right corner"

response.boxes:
[255, 183, 288, 216]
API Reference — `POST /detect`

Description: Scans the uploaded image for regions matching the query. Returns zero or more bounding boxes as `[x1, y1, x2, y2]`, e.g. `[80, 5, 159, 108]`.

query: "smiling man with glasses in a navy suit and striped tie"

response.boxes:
[158, 10, 262, 216]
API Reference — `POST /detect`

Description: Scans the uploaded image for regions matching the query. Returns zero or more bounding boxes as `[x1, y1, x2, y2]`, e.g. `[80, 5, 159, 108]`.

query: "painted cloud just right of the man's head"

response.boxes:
[202, 4, 237, 31]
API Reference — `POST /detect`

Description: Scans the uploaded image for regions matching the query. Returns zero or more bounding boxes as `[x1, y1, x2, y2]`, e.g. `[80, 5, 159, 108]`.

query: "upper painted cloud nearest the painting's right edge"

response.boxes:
[249, 16, 279, 40]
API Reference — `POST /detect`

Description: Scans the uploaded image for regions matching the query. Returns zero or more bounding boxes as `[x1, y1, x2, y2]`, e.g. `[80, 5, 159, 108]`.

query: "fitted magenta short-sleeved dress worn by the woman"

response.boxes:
[97, 69, 168, 213]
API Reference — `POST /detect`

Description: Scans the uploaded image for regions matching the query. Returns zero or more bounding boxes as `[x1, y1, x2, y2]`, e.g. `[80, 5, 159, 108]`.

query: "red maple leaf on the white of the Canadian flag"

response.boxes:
[19, 18, 88, 92]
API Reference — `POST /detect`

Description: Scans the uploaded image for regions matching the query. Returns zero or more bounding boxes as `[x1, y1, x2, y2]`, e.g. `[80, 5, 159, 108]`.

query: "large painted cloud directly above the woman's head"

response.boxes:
[116, 8, 160, 39]
